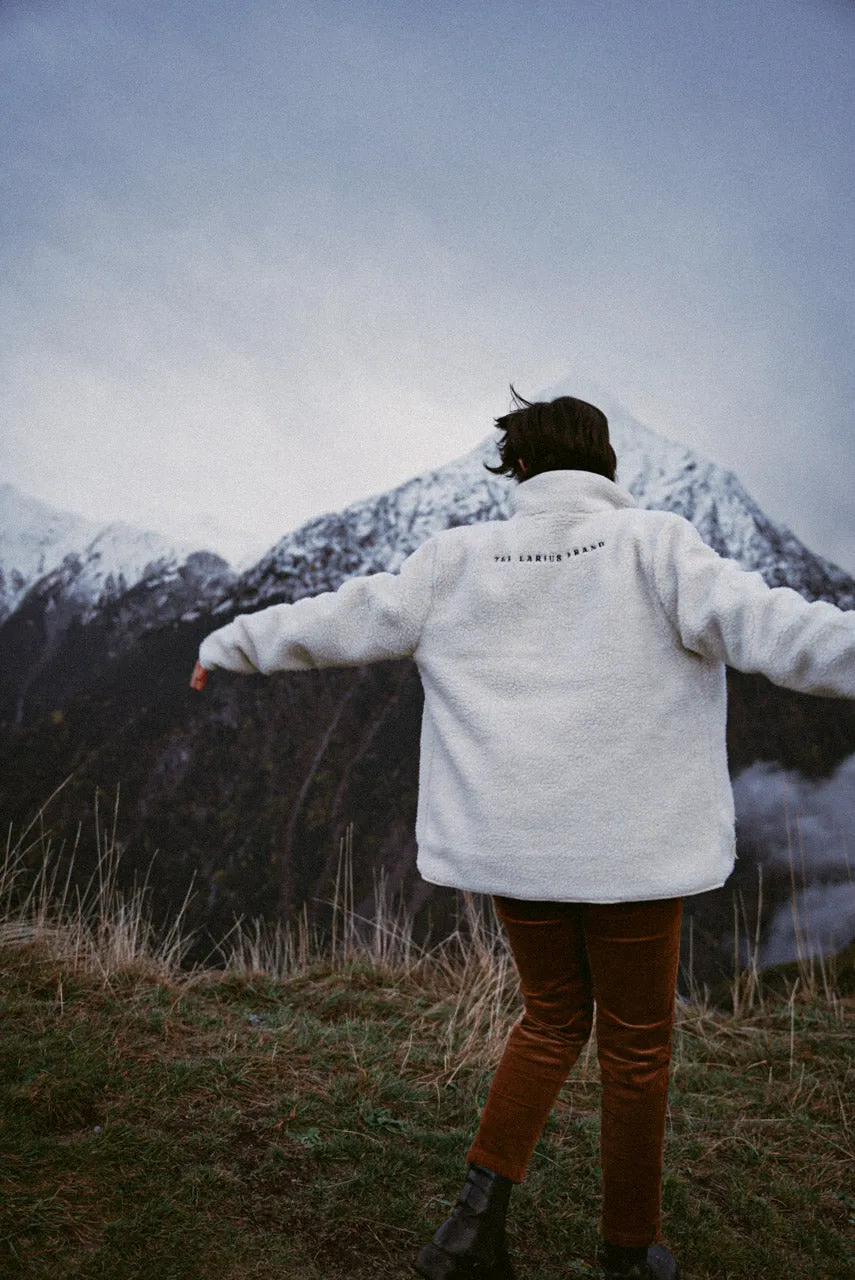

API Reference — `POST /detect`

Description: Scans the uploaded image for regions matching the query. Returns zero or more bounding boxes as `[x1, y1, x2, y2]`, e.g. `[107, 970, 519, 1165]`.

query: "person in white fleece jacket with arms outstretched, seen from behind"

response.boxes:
[193, 387, 855, 1280]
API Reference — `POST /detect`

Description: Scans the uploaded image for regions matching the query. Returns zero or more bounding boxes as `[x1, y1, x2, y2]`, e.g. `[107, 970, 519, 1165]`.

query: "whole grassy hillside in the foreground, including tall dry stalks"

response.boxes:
[0, 793, 855, 1280]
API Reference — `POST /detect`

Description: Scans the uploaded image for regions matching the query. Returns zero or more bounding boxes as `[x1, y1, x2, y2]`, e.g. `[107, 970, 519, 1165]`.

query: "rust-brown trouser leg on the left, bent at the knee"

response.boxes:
[466, 896, 594, 1183]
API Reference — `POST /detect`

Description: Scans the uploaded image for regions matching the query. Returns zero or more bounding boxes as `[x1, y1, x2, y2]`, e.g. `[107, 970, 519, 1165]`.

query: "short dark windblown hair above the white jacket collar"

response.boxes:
[484, 384, 617, 483]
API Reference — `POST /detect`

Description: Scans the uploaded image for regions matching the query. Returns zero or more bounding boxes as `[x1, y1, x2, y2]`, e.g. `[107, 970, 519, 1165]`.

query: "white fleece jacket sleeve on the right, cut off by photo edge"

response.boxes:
[654, 516, 855, 698]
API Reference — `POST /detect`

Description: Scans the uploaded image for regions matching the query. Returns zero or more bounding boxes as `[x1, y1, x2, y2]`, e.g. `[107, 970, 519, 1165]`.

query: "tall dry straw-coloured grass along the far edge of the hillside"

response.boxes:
[0, 780, 855, 1080]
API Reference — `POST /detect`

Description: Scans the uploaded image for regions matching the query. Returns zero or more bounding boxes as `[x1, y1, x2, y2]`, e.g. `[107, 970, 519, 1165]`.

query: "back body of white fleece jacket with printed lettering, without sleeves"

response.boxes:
[413, 470, 733, 902]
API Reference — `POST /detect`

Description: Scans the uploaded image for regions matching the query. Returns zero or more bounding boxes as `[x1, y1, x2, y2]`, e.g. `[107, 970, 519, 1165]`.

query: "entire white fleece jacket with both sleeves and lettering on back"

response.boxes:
[198, 471, 855, 902]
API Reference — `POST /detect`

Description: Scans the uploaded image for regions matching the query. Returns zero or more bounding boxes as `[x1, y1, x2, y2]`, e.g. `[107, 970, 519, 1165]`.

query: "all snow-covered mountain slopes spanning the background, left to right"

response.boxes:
[6, 397, 855, 623]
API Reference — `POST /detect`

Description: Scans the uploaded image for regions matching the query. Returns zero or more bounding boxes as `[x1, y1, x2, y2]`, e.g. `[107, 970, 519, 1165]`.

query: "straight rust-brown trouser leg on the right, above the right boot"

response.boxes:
[585, 897, 682, 1245]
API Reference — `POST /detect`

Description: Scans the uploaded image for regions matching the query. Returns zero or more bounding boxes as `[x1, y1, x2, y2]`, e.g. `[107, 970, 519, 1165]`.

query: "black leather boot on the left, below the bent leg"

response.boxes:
[413, 1165, 516, 1280]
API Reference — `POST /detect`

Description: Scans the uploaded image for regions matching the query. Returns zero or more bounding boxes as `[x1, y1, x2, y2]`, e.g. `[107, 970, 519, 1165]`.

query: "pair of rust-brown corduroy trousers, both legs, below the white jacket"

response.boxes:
[466, 896, 682, 1245]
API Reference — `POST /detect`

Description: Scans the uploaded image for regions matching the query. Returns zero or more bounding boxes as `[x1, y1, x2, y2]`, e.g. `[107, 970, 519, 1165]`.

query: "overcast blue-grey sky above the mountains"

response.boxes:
[0, 0, 855, 573]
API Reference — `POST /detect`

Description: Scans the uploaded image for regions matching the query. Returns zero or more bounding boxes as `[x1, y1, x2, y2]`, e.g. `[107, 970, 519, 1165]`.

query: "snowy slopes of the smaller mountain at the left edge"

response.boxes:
[0, 484, 234, 623]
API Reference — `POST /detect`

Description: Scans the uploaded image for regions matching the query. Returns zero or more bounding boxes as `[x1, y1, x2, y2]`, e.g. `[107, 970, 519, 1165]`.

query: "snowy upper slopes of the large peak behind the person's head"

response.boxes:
[200, 404, 855, 620]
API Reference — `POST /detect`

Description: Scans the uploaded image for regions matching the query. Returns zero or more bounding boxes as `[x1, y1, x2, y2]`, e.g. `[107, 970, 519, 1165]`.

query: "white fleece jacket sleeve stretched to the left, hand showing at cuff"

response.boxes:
[198, 539, 436, 676]
